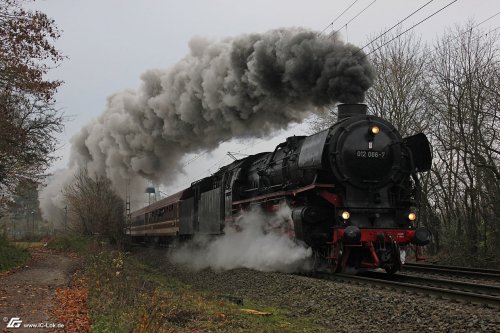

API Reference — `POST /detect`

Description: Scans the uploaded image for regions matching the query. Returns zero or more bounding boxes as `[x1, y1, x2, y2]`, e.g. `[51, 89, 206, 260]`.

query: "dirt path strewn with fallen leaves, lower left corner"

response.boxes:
[0, 250, 78, 333]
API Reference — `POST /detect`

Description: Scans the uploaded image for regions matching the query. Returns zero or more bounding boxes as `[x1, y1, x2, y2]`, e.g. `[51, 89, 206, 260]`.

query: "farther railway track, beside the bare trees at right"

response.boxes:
[402, 263, 500, 283]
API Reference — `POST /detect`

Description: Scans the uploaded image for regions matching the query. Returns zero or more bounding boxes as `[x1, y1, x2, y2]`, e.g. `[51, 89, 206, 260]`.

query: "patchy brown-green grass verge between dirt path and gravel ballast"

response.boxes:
[86, 250, 325, 332]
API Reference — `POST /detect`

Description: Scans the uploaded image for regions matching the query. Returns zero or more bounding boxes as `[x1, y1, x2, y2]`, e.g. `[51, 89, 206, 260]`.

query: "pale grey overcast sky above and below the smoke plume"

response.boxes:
[31, 0, 500, 205]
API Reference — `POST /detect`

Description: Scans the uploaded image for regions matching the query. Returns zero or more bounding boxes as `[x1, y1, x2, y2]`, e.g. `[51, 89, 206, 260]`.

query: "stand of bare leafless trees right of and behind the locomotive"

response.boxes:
[304, 26, 500, 264]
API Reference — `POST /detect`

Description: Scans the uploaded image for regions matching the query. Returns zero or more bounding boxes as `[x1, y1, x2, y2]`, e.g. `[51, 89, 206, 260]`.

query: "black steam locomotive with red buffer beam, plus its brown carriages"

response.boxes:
[127, 104, 432, 273]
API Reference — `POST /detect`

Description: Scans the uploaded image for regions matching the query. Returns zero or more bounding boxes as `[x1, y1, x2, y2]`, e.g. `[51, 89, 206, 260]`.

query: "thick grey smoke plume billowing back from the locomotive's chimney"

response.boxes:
[42, 28, 374, 218]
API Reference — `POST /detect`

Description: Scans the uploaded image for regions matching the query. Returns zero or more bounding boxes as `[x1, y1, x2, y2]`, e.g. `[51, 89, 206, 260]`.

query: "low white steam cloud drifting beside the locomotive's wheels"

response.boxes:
[169, 205, 312, 273]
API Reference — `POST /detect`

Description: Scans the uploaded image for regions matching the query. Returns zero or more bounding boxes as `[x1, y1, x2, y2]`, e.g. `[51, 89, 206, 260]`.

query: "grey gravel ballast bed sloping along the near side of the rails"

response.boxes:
[134, 249, 500, 332]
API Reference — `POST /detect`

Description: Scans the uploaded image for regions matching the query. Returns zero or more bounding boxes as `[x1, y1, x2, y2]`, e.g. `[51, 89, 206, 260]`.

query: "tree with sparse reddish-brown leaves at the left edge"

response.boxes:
[0, 0, 64, 206]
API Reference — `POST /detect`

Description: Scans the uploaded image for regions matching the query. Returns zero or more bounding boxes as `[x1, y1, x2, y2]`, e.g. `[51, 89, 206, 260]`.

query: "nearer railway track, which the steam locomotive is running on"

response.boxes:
[315, 272, 500, 308]
